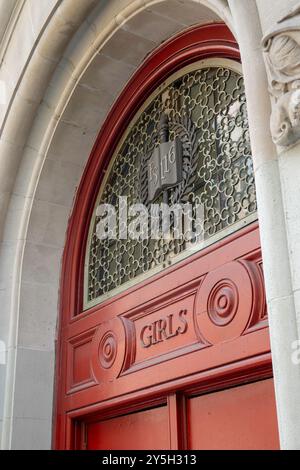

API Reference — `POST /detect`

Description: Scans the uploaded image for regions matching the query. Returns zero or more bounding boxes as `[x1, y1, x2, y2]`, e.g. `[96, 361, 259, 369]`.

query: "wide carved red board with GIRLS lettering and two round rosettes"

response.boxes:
[65, 223, 270, 408]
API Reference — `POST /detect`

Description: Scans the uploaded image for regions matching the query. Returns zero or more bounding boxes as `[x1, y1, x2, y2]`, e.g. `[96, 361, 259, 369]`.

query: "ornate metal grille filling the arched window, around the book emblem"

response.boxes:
[85, 59, 256, 308]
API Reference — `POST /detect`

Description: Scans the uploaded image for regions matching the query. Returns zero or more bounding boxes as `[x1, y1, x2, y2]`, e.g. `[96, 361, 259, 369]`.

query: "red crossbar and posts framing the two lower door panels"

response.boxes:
[65, 353, 276, 450]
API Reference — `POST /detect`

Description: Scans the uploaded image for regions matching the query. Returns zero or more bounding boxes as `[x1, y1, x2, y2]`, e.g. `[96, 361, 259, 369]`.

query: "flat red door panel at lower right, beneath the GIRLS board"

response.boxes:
[187, 379, 279, 450]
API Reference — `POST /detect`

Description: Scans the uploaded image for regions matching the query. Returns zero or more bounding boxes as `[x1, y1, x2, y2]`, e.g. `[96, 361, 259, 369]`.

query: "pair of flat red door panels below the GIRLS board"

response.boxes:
[83, 379, 279, 450]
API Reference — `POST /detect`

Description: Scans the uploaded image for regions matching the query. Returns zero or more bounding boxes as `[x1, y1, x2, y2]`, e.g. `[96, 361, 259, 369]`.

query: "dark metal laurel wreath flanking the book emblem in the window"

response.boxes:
[140, 115, 199, 206]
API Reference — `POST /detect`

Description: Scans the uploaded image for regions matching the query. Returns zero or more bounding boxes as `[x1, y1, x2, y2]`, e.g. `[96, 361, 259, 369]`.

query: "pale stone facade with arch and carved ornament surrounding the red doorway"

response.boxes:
[0, 0, 300, 449]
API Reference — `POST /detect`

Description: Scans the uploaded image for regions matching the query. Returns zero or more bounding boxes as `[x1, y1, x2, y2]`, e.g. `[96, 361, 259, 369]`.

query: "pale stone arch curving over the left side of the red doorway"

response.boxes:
[2, 0, 268, 448]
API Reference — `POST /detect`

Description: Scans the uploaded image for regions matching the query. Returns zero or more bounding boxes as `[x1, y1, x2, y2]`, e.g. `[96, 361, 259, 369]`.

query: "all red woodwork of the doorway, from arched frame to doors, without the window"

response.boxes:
[54, 24, 279, 449]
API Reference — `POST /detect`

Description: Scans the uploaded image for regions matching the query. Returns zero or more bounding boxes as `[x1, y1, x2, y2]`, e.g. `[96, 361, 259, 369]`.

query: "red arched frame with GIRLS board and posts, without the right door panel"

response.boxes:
[54, 24, 275, 449]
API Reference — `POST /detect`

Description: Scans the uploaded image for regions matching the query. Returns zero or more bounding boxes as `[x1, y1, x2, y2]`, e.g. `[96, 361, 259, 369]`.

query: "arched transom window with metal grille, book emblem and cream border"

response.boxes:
[84, 58, 256, 308]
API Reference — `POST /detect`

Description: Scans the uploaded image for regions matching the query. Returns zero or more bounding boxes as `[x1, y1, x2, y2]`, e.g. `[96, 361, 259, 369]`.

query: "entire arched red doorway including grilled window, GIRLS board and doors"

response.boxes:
[54, 24, 279, 449]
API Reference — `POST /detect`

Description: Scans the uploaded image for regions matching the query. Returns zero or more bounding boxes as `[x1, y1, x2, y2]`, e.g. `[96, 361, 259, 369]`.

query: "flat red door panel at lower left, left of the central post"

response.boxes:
[87, 406, 170, 450]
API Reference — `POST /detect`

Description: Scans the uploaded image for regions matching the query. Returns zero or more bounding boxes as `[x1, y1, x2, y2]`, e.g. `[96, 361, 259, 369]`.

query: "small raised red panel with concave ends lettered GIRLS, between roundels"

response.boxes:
[121, 283, 202, 373]
